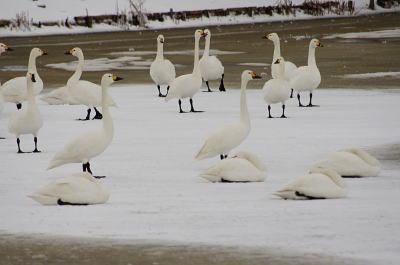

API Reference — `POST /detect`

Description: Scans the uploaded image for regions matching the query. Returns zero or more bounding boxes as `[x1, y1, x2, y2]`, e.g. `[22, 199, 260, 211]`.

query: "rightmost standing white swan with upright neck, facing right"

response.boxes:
[290, 39, 324, 107]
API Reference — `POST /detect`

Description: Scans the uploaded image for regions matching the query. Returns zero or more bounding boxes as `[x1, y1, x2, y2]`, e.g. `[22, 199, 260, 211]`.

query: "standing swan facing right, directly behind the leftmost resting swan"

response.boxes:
[47, 74, 122, 174]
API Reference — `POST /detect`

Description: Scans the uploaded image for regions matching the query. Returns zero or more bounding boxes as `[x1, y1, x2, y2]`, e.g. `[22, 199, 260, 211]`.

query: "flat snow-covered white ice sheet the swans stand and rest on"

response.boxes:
[0, 83, 400, 265]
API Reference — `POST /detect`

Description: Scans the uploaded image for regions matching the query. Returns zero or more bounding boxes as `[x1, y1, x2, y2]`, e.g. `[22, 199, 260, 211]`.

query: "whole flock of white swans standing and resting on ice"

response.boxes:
[0, 29, 381, 205]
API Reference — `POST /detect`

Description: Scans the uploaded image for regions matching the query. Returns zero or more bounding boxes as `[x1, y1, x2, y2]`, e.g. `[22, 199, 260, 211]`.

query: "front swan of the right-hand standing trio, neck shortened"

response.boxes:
[262, 57, 290, 118]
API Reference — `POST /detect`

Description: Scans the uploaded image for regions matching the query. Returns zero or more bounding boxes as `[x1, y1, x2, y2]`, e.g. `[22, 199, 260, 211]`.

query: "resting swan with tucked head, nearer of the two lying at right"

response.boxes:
[274, 168, 347, 200]
